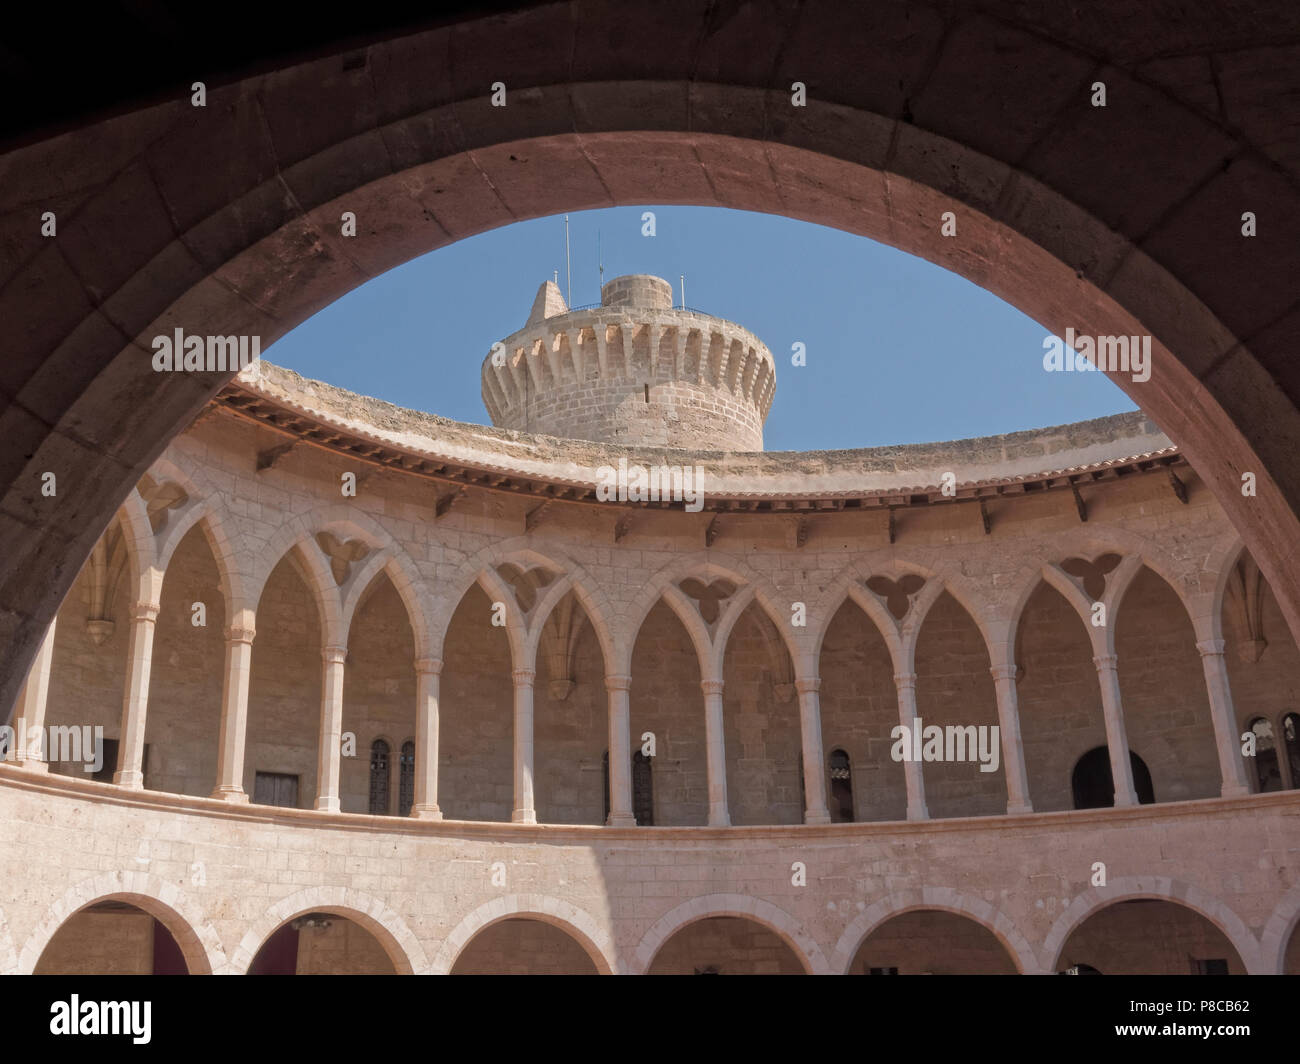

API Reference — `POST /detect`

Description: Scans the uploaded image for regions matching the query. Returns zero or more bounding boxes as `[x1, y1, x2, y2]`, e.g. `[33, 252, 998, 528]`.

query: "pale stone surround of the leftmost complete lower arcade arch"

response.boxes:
[17, 870, 226, 976]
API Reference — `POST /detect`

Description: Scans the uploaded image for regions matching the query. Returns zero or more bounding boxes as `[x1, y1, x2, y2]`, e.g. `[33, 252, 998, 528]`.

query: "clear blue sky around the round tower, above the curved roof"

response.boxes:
[263, 206, 1135, 450]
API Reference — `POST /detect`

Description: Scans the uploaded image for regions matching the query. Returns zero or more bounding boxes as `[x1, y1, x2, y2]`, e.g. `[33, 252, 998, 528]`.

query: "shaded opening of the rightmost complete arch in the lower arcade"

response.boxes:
[1052, 898, 1249, 976]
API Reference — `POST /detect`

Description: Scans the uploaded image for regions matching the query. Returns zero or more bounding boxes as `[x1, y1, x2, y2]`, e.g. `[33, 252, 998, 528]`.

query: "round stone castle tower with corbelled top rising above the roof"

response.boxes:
[482, 273, 776, 451]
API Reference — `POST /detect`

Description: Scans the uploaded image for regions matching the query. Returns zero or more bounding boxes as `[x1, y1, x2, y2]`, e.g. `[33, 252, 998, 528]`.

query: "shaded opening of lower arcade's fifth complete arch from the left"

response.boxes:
[846, 908, 1021, 976]
